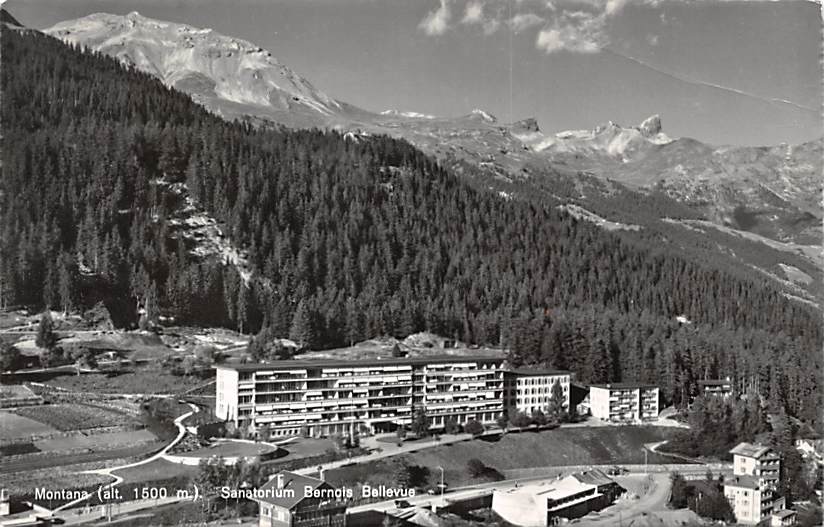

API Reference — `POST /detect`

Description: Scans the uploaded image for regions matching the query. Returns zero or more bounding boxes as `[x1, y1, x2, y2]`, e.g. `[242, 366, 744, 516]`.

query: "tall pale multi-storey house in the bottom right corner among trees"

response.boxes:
[724, 443, 786, 525]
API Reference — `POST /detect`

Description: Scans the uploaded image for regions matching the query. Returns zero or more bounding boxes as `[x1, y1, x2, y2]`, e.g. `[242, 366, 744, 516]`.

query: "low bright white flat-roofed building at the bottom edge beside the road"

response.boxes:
[492, 470, 624, 527]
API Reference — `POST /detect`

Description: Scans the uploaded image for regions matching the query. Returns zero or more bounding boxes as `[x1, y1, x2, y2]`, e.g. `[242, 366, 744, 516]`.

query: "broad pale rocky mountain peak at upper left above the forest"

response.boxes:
[45, 11, 342, 125]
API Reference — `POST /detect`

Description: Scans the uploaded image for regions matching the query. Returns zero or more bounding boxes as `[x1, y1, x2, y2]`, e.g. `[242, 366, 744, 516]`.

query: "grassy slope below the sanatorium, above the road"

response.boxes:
[326, 426, 684, 487]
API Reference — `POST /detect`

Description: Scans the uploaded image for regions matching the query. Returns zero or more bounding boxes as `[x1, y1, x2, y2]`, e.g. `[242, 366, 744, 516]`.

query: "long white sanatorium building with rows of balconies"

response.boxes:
[215, 356, 504, 436]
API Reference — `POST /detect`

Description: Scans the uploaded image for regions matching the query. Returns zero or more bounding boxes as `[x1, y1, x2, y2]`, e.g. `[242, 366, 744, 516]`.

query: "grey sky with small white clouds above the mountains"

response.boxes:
[5, 0, 824, 145]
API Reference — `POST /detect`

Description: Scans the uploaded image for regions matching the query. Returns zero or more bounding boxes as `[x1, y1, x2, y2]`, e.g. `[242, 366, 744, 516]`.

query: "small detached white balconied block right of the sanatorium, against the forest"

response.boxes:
[589, 382, 658, 423]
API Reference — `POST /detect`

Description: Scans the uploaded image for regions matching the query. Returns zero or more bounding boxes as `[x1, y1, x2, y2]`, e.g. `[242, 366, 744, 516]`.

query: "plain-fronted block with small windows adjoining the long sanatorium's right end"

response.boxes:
[504, 368, 572, 416]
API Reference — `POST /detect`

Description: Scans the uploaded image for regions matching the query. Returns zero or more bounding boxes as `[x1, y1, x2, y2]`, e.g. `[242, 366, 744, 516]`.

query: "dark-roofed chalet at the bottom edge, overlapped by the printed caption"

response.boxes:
[252, 471, 347, 527]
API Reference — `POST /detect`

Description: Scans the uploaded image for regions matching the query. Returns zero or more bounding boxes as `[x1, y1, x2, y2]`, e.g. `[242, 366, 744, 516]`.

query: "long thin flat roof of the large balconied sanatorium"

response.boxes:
[215, 355, 505, 371]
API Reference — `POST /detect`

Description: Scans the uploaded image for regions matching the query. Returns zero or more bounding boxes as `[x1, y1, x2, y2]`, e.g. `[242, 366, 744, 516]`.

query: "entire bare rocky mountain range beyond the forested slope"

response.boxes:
[45, 12, 824, 300]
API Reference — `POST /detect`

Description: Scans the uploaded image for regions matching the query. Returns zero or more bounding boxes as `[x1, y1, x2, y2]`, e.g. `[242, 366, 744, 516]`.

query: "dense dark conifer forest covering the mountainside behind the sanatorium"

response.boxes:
[0, 30, 822, 422]
